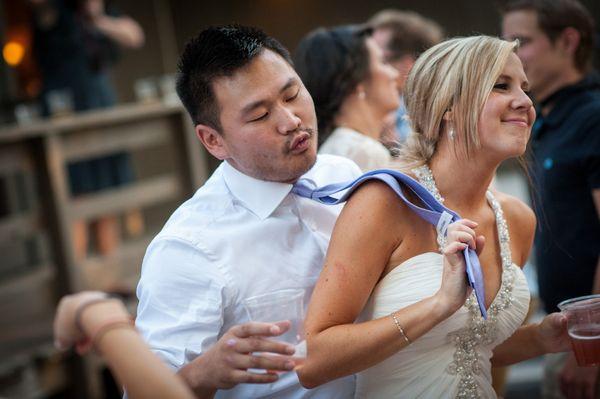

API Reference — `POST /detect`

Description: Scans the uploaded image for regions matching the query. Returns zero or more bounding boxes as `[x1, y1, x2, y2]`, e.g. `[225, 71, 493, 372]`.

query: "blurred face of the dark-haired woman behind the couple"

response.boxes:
[362, 38, 400, 115]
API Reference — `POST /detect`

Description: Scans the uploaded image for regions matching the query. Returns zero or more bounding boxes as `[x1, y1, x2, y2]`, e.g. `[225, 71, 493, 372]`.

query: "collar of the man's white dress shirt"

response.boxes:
[223, 162, 292, 219]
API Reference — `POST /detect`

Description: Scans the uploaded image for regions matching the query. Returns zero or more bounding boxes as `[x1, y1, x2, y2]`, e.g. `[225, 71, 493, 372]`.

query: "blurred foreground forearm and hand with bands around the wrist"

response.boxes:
[54, 292, 193, 399]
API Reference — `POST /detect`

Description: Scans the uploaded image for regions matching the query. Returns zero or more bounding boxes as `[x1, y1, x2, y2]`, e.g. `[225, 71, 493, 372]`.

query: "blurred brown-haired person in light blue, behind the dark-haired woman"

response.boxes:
[367, 9, 444, 142]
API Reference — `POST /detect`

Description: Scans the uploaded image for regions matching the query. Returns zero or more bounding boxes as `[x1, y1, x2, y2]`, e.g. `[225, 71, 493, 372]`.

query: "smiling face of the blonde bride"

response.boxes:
[479, 53, 535, 159]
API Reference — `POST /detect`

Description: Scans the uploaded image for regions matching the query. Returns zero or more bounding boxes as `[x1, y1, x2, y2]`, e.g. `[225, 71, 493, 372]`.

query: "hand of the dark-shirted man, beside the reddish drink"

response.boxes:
[558, 353, 598, 399]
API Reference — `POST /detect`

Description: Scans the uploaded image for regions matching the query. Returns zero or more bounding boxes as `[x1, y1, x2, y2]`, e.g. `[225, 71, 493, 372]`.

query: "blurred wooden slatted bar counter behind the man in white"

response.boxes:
[0, 103, 210, 399]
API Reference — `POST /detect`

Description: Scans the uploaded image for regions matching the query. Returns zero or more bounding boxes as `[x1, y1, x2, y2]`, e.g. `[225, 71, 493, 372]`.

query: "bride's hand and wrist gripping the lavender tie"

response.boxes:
[436, 219, 485, 314]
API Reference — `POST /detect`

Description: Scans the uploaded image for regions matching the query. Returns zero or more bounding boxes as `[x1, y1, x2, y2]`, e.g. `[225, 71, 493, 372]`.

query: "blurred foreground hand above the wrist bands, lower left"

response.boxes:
[54, 291, 107, 350]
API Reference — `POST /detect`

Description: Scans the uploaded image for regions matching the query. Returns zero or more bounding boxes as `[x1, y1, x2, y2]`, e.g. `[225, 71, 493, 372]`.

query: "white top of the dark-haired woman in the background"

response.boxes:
[319, 127, 392, 172]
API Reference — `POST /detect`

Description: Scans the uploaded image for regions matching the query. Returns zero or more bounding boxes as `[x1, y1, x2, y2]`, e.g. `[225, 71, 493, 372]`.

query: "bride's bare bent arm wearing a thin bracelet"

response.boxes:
[298, 182, 475, 388]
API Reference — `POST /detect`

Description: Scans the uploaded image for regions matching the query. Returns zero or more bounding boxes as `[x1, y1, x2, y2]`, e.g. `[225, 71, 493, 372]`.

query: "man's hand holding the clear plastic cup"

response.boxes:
[179, 321, 296, 398]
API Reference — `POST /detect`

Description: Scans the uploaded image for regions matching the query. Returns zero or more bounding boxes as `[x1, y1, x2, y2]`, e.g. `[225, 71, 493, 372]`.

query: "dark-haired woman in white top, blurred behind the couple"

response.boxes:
[294, 25, 399, 172]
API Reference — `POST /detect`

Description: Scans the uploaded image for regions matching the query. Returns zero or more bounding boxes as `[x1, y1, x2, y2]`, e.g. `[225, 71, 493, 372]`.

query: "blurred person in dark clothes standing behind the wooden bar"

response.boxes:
[29, 0, 144, 259]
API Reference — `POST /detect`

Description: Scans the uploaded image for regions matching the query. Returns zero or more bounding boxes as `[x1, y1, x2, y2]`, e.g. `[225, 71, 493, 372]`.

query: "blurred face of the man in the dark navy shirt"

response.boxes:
[502, 10, 570, 100]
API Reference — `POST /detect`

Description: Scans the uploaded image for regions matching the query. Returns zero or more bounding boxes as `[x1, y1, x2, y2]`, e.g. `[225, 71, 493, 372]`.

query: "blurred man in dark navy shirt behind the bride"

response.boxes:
[502, 0, 600, 398]
